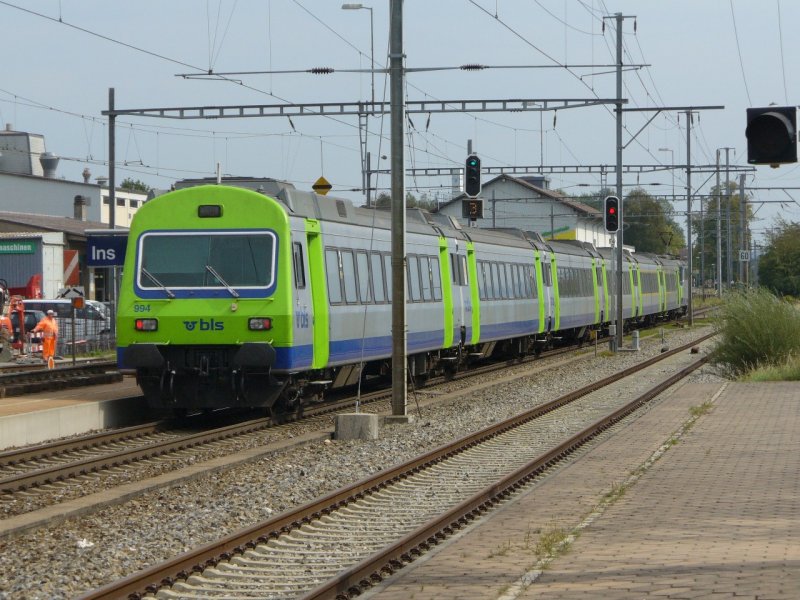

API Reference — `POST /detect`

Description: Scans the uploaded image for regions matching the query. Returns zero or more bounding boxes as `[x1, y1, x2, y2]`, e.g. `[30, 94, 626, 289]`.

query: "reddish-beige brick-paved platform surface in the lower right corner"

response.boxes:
[370, 383, 800, 600]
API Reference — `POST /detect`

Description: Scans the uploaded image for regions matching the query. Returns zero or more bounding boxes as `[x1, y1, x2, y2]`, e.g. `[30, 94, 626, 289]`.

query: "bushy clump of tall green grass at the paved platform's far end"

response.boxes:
[711, 289, 800, 376]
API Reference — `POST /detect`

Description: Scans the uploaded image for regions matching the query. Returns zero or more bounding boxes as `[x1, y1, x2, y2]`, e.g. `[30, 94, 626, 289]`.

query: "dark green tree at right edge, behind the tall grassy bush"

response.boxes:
[758, 219, 800, 297]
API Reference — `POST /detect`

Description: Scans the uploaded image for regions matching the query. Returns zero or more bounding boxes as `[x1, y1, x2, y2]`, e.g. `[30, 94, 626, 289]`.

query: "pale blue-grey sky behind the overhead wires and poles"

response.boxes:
[0, 0, 800, 244]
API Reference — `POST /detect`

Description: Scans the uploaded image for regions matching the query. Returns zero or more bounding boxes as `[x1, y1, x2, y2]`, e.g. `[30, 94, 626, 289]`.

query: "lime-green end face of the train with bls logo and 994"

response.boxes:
[117, 185, 292, 411]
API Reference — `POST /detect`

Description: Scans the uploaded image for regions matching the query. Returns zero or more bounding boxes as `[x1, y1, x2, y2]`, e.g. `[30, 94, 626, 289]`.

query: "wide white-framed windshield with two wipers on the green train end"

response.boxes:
[138, 231, 275, 290]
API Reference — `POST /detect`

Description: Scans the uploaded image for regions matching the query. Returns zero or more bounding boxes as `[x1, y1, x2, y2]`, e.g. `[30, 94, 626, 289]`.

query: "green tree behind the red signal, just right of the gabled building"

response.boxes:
[622, 188, 686, 254]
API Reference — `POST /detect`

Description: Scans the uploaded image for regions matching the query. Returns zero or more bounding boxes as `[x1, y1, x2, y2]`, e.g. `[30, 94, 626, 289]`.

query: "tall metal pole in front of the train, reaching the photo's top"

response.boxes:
[389, 0, 408, 419]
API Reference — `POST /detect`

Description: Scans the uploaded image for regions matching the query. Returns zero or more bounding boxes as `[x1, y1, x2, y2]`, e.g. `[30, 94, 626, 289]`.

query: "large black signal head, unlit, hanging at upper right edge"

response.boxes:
[744, 106, 797, 167]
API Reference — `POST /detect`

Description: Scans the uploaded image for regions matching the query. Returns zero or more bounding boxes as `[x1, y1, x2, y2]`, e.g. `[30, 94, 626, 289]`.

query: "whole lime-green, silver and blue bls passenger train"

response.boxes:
[117, 185, 686, 410]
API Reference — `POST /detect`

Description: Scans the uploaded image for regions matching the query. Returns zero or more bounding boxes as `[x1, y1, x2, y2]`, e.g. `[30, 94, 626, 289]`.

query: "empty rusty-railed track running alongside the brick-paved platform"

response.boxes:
[84, 336, 710, 599]
